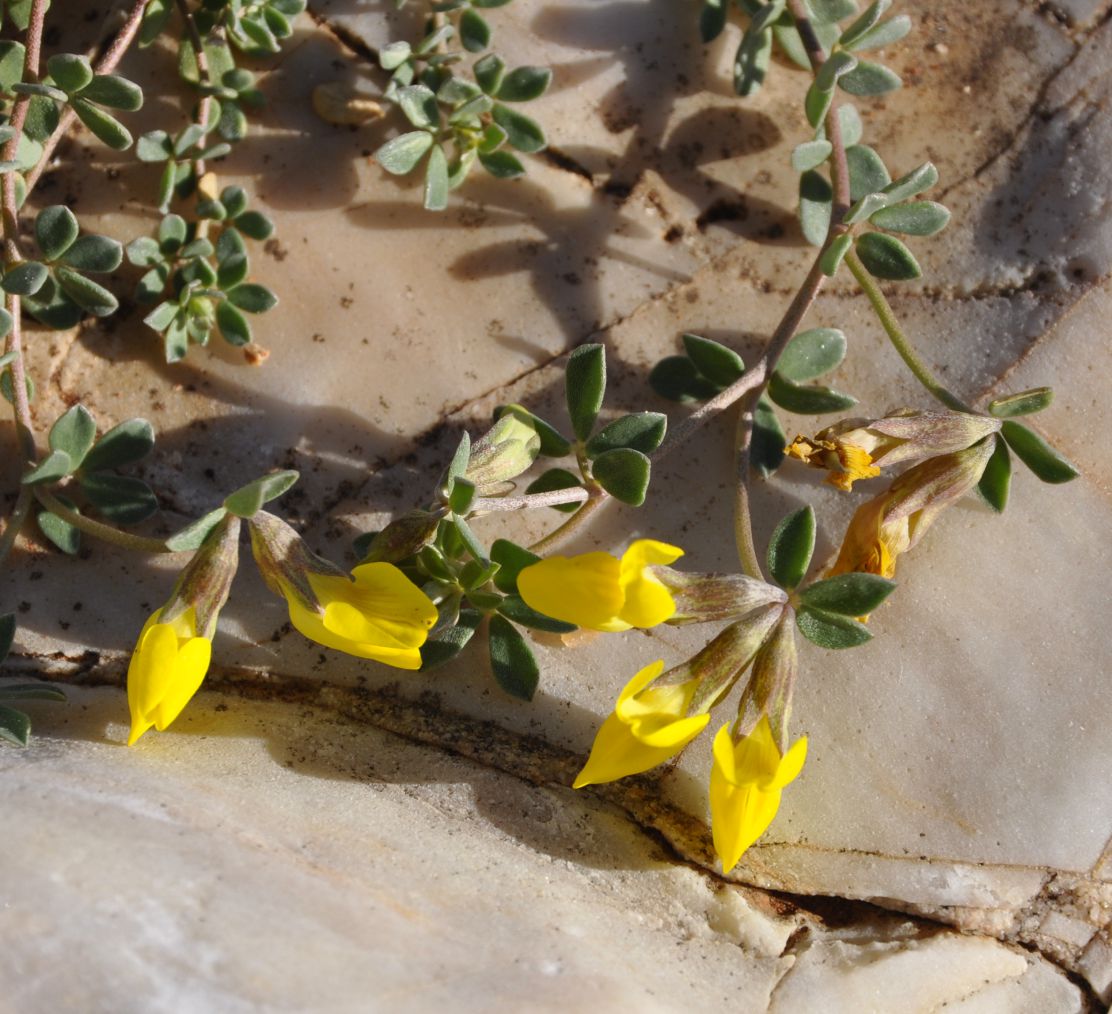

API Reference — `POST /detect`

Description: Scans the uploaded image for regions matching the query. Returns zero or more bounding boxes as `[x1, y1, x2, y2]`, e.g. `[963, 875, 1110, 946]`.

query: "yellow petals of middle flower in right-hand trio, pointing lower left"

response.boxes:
[572, 662, 711, 788]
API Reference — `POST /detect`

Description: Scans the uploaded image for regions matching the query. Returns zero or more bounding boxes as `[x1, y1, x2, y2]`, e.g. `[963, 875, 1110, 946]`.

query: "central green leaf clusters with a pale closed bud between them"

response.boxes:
[355, 345, 653, 700]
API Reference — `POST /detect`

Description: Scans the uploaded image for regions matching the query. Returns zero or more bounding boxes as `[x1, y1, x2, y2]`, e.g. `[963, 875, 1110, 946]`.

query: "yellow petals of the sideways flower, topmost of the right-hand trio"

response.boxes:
[517, 539, 684, 632]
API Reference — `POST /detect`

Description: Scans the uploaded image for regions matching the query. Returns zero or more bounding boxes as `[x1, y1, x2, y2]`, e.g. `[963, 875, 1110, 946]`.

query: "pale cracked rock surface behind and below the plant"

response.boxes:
[0, 0, 1112, 1011]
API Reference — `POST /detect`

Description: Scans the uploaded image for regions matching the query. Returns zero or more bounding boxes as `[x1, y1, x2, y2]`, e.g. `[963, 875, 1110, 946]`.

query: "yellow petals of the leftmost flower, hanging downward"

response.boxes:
[128, 606, 212, 746]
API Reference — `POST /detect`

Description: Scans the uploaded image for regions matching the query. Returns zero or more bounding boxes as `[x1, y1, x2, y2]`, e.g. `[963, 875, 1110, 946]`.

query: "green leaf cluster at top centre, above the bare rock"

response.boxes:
[375, 0, 552, 211]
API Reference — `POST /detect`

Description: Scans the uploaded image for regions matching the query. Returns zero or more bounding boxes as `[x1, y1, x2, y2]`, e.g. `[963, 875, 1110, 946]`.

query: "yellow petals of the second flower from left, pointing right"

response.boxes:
[282, 563, 437, 669]
